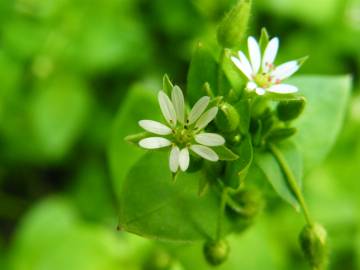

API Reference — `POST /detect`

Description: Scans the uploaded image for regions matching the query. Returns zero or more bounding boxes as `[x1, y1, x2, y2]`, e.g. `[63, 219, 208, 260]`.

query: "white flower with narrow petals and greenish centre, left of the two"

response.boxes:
[139, 86, 225, 173]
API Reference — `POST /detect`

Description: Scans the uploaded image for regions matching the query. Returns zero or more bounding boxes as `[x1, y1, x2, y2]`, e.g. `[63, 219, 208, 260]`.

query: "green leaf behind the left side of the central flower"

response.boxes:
[108, 85, 161, 195]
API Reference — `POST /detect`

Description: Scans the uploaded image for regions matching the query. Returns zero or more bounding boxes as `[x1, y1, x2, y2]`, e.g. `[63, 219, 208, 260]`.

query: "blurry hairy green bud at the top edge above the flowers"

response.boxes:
[217, 0, 251, 48]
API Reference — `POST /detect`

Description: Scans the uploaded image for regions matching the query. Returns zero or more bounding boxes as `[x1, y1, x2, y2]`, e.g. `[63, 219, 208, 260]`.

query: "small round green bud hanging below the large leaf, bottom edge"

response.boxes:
[203, 240, 230, 266]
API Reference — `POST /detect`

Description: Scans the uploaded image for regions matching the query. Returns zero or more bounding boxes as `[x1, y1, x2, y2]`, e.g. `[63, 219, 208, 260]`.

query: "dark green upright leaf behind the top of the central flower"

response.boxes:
[187, 43, 218, 105]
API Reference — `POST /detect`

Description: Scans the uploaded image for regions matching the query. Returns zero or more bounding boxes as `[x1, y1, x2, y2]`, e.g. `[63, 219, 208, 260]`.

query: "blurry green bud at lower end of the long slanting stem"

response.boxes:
[299, 224, 328, 270]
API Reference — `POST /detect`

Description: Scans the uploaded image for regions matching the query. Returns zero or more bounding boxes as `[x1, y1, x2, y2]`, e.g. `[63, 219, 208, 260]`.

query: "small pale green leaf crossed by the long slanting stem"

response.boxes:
[254, 141, 303, 209]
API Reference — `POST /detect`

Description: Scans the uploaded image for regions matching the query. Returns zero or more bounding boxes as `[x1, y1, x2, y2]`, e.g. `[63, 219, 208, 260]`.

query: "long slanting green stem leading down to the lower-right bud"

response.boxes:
[268, 144, 313, 226]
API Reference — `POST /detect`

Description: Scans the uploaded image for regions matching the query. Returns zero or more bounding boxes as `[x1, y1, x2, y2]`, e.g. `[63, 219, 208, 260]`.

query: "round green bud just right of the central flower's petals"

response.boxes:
[215, 102, 240, 132]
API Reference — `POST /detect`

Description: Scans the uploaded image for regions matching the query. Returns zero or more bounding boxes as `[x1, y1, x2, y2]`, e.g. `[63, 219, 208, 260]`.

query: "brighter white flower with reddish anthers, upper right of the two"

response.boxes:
[231, 37, 301, 95]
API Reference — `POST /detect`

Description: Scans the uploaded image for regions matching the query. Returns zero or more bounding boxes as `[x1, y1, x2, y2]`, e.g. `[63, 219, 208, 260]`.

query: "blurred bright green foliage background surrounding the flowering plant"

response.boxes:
[0, 0, 360, 270]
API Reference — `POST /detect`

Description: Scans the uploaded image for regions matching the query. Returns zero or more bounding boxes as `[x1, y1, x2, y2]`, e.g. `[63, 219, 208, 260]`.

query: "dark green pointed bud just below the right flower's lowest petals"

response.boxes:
[276, 97, 306, 121]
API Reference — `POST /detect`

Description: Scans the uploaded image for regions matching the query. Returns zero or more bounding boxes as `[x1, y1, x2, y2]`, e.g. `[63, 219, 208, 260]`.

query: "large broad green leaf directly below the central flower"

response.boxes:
[120, 151, 228, 242]
